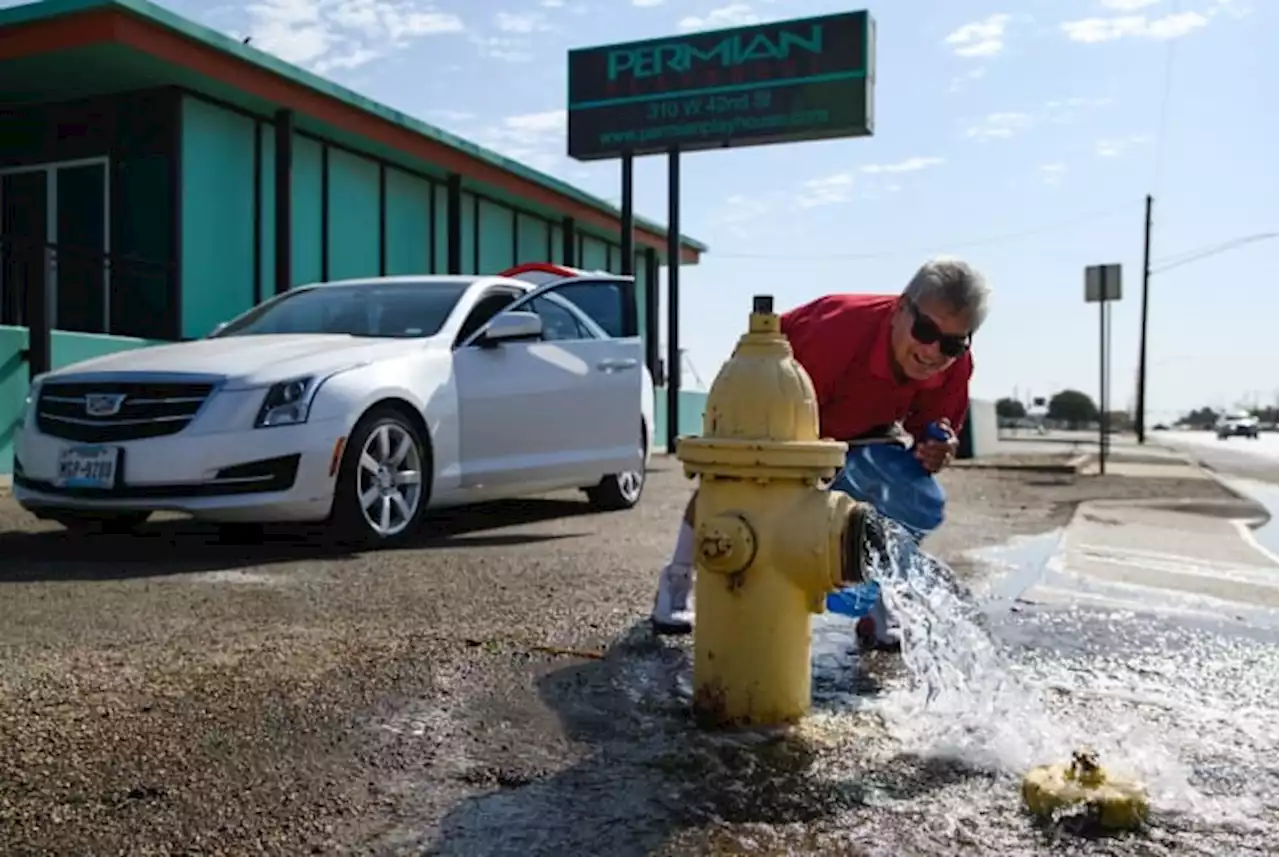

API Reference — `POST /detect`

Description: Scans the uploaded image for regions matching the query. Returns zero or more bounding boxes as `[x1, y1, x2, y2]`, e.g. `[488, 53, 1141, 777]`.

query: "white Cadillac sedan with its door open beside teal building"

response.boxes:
[13, 265, 653, 545]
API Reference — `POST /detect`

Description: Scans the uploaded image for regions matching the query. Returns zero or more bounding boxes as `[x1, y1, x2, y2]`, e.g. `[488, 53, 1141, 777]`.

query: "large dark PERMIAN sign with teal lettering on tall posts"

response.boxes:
[568, 12, 876, 450]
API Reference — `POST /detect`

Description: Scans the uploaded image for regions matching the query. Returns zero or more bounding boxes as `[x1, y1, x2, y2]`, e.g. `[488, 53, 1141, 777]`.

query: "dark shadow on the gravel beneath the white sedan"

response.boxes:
[0, 498, 596, 583]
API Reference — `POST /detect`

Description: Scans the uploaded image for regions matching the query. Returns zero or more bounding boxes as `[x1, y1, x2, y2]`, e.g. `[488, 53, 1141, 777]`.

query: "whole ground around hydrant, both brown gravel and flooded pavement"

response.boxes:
[0, 463, 1280, 857]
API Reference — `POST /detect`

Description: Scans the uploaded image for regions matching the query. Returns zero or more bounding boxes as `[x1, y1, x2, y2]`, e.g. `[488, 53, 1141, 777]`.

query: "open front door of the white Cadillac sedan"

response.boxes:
[454, 280, 643, 489]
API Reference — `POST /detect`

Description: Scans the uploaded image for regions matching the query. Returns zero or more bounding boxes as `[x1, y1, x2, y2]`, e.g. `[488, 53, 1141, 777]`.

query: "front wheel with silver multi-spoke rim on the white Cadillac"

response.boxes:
[330, 405, 433, 547]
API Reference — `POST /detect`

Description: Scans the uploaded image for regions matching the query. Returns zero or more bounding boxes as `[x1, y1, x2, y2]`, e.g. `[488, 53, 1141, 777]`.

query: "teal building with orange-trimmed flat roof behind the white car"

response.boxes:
[0, 0, 707, 473]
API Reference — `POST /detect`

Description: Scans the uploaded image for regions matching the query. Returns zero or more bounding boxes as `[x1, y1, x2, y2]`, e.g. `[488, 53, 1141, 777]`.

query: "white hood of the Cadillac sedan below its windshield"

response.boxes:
[46, 334, 440, 388]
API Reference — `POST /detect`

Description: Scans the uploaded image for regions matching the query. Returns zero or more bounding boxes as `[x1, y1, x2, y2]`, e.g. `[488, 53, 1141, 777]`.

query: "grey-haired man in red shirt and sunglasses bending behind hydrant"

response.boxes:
[652, 258, 989, 646]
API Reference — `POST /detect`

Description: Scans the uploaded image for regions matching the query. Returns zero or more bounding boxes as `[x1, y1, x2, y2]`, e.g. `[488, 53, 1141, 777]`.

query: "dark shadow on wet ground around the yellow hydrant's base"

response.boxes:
[425, 624, 973, 857]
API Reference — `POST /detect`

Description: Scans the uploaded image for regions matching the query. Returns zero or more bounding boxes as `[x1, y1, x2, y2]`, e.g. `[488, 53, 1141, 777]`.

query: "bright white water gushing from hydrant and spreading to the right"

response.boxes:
[815, 522, 1280, 853]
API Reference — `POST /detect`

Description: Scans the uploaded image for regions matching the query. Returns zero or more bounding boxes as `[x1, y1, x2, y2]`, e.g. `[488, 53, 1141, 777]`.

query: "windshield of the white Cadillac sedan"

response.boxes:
[212, 280, 470, 339]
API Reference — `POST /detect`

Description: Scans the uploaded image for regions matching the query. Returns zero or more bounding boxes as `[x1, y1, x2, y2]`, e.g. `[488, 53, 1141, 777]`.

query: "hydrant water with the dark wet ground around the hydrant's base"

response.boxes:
[414, 514, 1280, 857]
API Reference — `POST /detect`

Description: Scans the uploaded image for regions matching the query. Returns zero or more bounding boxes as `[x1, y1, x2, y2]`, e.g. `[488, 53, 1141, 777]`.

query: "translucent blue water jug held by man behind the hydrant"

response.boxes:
[827, 423, 947, 619]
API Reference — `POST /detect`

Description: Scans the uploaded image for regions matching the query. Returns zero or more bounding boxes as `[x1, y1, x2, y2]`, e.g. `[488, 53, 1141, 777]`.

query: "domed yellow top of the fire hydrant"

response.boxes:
[703, 295, 818, 443]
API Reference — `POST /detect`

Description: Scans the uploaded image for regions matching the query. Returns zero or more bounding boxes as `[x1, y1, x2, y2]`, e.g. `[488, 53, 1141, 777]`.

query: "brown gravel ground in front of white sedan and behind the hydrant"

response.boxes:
[0, 460, 1239, 857]
